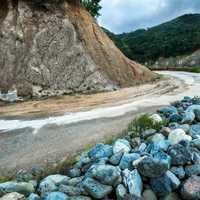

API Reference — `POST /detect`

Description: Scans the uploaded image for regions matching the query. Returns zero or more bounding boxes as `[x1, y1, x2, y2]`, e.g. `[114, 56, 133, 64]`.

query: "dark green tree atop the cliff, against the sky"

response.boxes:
[82, 0, 101, 18]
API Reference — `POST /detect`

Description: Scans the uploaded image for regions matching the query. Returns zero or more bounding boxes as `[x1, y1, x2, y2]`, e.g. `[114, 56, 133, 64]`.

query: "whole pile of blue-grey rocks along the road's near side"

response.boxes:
[0, 97, 200, 200]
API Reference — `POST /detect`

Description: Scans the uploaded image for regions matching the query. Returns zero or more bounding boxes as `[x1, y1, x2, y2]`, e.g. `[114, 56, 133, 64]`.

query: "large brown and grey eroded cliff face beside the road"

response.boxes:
[0, 0, 154, 97]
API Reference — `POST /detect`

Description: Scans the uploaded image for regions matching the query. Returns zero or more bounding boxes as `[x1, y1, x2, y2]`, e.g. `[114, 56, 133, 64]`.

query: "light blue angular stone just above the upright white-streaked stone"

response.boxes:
[119, 153, 140, 170]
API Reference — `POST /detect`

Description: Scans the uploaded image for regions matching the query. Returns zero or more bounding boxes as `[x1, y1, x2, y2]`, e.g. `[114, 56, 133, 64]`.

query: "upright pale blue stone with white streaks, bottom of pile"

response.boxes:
[126, 169, 143, 197]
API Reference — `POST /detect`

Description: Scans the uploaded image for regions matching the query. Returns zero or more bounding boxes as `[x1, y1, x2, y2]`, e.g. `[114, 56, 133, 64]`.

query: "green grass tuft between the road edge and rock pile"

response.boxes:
[128, 114, 165, 137]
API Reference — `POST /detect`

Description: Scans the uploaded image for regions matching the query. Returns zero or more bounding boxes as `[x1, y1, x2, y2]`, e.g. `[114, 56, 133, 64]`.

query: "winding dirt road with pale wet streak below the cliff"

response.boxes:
[0, 71, 200, 174]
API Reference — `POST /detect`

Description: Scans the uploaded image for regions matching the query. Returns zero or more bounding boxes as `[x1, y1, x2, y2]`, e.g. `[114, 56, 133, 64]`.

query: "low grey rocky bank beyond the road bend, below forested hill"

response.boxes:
[151, 50, 200, 69]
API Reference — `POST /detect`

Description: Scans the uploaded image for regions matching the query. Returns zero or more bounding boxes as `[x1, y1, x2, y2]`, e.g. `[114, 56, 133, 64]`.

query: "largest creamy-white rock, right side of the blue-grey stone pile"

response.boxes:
[168, 129, 192, 145]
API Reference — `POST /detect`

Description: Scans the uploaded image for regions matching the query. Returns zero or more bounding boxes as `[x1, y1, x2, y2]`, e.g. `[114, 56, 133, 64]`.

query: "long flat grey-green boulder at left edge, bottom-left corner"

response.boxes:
[0, 182, 35, 197]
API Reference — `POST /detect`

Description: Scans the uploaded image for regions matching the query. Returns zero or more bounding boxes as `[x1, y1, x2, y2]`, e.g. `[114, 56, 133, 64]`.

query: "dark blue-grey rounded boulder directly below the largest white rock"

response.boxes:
[168, 144, 192, 165]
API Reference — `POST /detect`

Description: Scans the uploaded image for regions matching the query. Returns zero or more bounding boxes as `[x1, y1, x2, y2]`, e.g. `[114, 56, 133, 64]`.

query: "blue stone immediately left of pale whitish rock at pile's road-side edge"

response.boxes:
[88, 144, 113, 159]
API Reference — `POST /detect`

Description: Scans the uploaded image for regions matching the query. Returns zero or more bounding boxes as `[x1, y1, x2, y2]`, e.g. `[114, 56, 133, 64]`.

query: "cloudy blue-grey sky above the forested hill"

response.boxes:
[98, 0, 200, 33]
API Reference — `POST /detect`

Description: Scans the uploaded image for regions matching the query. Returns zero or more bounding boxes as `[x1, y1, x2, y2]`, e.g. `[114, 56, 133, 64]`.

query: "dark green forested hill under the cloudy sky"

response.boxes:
[106, 14, 200, 63]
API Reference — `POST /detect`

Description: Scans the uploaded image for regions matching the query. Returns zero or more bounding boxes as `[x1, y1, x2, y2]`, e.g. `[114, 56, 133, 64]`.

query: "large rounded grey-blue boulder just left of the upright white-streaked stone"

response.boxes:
[92, 165, 121, 186]
